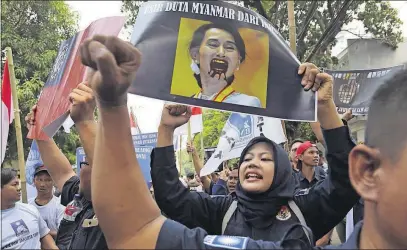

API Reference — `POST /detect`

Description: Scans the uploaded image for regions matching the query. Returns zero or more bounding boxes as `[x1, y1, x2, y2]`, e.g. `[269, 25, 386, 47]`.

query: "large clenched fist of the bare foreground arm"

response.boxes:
[80, 35, 141, 107]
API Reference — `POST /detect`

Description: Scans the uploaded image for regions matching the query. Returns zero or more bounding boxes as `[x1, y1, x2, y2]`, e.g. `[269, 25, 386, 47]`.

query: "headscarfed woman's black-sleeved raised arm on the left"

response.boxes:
[151, 105, 232, 233]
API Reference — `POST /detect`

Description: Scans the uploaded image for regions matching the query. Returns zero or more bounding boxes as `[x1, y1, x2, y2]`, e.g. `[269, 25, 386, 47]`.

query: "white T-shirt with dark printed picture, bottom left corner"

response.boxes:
[1, 202, 49, 249]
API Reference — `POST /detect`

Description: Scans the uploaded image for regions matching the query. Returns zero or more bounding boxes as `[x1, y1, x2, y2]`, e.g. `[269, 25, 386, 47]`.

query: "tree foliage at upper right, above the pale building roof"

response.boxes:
[244, 0, 402, 68]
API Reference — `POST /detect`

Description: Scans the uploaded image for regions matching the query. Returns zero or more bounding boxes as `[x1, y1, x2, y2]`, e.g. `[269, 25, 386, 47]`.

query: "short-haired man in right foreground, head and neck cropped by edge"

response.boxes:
[324, 70, 407, 249]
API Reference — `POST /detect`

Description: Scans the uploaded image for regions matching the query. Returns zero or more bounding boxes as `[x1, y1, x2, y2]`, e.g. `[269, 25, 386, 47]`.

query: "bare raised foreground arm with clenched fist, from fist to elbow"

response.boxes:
[81, 36, 165, 249]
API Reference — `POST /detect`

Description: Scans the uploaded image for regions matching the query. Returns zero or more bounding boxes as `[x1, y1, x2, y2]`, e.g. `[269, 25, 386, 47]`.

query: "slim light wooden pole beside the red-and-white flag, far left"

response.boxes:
[6, 47, 27, 203]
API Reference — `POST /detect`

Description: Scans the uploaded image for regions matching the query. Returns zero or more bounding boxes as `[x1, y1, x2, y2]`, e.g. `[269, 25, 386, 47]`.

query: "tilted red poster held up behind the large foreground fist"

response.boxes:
[28, 16, 125, 140]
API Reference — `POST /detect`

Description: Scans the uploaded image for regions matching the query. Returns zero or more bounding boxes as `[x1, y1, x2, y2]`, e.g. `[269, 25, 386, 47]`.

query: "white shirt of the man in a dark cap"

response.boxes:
[28, 196, 65, 231]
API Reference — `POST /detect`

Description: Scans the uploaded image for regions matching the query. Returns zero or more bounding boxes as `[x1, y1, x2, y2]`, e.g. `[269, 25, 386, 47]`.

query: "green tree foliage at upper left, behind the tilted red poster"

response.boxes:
[1, 0, 79, 163]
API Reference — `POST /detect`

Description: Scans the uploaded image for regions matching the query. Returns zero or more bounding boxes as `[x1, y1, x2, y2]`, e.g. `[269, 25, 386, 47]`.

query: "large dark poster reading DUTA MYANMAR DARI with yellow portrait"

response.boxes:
[130, 1, 316, 121]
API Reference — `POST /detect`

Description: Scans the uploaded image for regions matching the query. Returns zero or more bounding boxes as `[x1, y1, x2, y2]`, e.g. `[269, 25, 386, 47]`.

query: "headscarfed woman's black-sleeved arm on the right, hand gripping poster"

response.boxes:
[295, 73, 359, 239]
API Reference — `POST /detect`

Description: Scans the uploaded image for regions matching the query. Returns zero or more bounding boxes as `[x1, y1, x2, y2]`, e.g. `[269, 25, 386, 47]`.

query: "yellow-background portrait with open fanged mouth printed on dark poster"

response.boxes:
[171, 18, 269, 108]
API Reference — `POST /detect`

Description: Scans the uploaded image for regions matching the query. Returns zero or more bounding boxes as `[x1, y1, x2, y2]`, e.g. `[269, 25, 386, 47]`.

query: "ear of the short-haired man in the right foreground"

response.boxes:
[349, 144, 382, 202]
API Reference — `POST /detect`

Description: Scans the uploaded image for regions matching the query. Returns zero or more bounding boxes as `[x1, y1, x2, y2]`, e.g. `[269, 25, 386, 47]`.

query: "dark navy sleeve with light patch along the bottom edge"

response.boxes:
[156, 219, 293, 249]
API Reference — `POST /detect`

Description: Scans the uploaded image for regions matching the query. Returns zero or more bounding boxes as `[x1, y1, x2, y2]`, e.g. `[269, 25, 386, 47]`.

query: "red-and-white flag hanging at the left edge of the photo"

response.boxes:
[0, 60, 14, 163]
